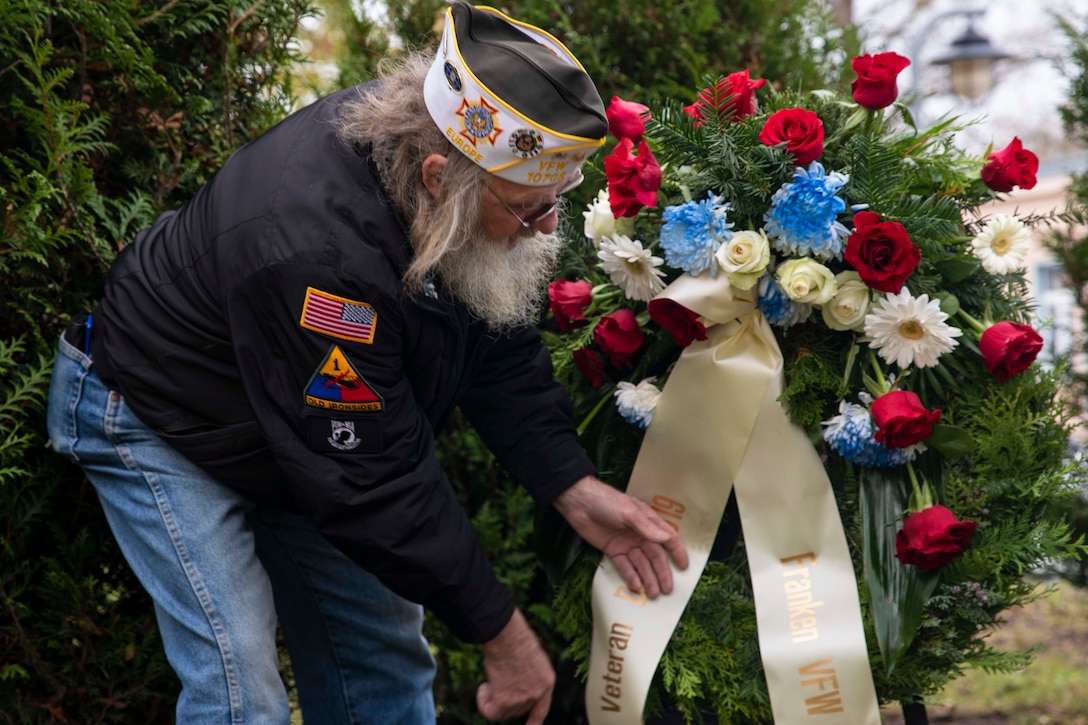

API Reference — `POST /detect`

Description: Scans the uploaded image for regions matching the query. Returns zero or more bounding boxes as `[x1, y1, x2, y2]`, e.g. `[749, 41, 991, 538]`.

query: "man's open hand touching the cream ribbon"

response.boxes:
[555, 476, 688, 599]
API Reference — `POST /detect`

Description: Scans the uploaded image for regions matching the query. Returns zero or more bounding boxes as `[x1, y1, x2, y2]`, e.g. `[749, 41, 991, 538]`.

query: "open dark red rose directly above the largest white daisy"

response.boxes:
[842, 211, 922, 293]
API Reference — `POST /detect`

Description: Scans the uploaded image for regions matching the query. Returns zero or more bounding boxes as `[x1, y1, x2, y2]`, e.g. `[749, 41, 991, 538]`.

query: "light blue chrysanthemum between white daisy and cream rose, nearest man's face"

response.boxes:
[660, 192, 733, 277]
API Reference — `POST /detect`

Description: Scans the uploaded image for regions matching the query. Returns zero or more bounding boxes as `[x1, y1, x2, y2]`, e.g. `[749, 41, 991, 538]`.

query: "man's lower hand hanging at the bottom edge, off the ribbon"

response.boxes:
[477, 611, 555, 725]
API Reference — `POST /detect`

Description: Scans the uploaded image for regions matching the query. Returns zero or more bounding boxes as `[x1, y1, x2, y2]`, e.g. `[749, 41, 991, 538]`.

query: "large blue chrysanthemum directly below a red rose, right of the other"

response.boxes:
[763, 161, 850, 261]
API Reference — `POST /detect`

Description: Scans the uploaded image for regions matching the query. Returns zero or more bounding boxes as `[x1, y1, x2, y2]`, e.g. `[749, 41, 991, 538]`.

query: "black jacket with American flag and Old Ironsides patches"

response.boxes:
[91, 81, 594, 642]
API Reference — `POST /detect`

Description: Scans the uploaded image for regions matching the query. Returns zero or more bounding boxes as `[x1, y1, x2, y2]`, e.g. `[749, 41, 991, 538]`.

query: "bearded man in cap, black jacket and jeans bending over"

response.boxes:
[49, 3, 687, 725]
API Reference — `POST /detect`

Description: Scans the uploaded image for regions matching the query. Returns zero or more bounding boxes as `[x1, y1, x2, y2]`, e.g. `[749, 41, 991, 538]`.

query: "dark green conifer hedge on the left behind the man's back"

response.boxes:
[0, 0, 310, 724]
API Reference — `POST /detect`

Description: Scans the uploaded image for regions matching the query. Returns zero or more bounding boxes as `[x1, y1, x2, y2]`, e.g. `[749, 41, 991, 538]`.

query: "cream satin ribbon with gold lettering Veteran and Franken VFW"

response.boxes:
[585, 274, 880, 725]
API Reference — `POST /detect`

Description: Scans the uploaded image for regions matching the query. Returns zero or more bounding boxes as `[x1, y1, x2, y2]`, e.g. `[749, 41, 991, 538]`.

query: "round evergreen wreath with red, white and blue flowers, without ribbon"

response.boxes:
[543, 52, 1080, 723]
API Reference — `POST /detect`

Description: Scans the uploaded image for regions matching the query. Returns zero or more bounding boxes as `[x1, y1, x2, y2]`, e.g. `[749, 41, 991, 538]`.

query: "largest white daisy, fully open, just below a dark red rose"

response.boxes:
[865, 287, 963, 368]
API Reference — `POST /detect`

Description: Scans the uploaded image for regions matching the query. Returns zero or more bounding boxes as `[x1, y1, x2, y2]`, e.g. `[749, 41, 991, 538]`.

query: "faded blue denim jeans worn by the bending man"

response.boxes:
[49, 330, 435, 725]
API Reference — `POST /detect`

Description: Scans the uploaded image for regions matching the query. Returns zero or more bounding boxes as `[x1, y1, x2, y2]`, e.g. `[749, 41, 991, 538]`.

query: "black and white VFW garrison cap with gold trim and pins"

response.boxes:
[423, 2, 608, 186]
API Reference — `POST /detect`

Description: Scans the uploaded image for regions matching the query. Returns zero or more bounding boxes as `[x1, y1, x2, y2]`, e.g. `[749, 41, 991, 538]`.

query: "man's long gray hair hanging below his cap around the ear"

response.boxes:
[338, 52, 486, 293]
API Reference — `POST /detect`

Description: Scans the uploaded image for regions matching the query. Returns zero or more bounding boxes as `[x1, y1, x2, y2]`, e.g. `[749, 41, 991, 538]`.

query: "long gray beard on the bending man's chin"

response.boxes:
[436, 231, 562, 332]
